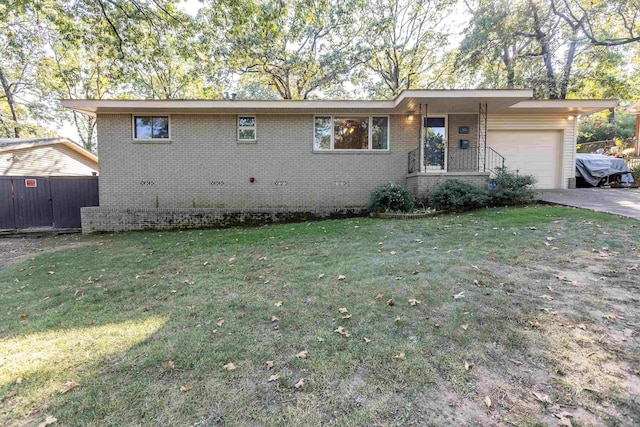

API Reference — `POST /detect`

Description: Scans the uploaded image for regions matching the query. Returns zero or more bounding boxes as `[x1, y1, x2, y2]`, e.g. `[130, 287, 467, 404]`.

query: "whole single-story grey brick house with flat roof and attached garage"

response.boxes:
[62, 90, 616, 231]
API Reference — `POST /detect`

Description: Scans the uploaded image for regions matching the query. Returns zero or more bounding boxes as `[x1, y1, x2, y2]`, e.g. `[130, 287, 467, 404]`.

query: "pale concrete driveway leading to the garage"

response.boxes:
[538, 188, 640, 220]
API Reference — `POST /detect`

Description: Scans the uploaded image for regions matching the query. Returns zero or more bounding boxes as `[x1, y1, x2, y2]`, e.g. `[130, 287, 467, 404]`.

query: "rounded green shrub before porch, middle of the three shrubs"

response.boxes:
[427, 178, 487, 211]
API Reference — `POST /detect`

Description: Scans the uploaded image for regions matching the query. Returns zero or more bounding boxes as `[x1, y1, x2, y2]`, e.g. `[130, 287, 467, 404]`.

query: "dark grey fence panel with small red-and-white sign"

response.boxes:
[13, 176, 53, 228]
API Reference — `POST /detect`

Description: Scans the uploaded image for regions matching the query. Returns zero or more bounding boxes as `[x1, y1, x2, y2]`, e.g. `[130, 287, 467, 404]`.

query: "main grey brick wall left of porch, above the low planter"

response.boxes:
[98, 114, 420, 208]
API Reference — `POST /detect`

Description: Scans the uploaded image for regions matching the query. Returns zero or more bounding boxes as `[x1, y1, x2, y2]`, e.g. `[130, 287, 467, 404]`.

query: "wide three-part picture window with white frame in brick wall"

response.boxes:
[313, 116, 389, 151]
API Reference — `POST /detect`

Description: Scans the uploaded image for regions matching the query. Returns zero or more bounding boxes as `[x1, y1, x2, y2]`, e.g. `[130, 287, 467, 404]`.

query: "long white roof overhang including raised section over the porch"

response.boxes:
[61, 89, 533, 116]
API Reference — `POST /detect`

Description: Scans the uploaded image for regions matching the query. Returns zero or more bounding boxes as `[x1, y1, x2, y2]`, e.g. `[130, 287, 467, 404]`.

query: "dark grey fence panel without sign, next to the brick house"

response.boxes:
[50, 177, 99, 228]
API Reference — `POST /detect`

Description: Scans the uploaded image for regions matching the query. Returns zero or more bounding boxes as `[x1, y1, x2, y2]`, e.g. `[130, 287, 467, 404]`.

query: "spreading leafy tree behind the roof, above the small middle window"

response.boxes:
[200, 0, 367, 99]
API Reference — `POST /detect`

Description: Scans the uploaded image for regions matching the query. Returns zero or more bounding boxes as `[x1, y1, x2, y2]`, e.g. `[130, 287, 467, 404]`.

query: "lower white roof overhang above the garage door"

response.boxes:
[496, 99, 618, 116]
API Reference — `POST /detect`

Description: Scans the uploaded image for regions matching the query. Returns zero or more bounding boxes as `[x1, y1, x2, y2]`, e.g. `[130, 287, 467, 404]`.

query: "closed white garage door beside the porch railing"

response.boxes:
[487, 130, 562, 189]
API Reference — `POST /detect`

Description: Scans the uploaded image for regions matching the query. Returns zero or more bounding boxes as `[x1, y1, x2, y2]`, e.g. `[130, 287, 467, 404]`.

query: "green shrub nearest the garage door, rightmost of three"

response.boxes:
[488, 168, 536, 206]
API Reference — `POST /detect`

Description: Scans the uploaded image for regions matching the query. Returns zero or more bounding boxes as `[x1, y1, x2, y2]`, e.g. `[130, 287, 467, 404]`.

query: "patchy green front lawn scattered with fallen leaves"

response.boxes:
[0, 206, 640, 426]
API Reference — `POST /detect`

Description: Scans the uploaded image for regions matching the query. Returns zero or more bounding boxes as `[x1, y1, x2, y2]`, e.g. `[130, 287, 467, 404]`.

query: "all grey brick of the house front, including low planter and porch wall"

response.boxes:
[89, 112, 486, 232]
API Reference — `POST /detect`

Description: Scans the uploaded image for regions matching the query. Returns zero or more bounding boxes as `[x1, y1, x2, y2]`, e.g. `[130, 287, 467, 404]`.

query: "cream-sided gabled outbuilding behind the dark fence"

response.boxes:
[0, 138, 98, 176]
